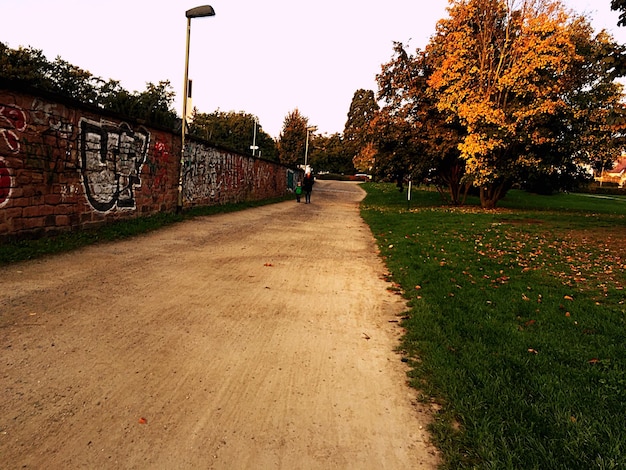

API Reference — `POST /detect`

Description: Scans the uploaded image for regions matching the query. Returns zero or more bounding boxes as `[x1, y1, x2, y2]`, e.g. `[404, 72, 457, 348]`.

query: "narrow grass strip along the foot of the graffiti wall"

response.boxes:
[0, 195, 293, 266]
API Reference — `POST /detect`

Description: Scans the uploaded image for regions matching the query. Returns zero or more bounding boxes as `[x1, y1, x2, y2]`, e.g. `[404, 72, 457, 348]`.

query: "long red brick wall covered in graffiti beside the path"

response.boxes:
[0, 83, 292, 239]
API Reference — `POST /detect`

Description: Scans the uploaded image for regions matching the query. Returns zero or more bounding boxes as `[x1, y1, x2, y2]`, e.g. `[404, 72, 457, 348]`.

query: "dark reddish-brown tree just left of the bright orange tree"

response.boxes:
[372, 42, 468, 204]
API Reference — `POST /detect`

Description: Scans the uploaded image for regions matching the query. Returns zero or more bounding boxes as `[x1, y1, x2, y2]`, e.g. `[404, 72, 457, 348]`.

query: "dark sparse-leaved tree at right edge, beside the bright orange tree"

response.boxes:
[520, 18, 625, 193]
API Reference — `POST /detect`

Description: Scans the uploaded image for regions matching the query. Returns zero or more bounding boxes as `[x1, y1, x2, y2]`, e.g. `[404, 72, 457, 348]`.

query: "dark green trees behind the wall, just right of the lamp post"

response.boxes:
[189, 109, 278, 161]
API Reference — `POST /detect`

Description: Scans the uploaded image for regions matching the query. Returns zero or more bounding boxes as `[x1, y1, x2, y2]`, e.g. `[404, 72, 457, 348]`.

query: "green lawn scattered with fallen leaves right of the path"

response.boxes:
[362, 184, 626, 469]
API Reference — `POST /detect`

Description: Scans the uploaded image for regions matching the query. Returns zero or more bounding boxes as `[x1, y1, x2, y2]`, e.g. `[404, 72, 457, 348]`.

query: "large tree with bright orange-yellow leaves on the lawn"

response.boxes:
[429, 0, 608, 208]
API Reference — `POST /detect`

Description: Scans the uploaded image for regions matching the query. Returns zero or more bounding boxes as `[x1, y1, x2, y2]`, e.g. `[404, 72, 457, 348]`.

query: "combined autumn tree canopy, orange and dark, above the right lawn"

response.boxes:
[372, 0, 624, 208]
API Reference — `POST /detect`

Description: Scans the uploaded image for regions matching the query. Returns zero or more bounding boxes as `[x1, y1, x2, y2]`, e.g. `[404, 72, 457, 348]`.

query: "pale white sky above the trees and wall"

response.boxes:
[0, 0, 626, 138]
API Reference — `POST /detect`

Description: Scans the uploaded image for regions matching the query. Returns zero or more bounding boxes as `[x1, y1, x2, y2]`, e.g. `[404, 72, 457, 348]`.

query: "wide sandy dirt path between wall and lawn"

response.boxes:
[0, 181, 437, 470]
